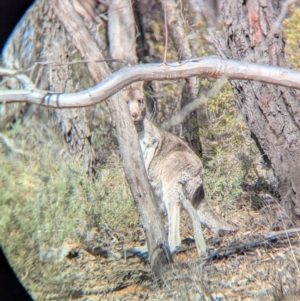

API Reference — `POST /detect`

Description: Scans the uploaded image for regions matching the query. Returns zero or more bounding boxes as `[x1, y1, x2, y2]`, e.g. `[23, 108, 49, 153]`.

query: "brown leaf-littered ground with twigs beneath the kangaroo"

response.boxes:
[37, 198, 300, 301]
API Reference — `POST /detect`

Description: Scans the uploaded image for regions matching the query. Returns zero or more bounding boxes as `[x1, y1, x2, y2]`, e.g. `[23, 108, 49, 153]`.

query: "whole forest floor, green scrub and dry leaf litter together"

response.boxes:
[0, 102, 300, 301]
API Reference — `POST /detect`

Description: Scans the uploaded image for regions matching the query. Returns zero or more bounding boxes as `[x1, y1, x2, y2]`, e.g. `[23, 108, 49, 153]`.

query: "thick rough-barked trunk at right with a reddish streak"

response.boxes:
[215, 0, 300, 229]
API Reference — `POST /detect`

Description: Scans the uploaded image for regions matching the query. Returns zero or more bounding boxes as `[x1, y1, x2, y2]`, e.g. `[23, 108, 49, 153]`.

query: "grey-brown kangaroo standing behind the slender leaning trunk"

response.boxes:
[123, 82, 236, 253]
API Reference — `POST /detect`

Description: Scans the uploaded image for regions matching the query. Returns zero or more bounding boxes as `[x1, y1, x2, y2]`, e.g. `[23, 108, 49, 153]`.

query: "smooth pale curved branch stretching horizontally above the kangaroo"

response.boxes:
[0, 57, 300, 108]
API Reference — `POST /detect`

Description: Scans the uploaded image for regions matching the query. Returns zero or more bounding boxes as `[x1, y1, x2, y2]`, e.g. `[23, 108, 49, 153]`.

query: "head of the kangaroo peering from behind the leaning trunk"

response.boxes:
[123, 82, 146, 131]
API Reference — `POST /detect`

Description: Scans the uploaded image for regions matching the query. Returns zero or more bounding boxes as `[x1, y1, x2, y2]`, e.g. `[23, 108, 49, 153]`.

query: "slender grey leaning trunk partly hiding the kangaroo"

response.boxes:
[52, 0, 172, 276]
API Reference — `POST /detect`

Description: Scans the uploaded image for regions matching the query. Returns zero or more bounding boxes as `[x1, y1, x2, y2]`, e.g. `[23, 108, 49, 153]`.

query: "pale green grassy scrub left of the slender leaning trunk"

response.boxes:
[0, 117, 138, 300]
